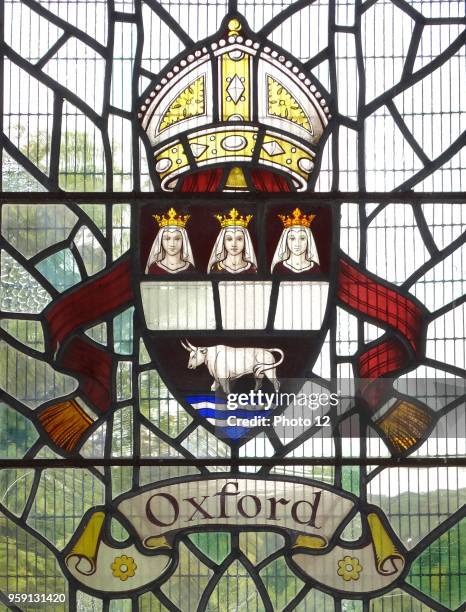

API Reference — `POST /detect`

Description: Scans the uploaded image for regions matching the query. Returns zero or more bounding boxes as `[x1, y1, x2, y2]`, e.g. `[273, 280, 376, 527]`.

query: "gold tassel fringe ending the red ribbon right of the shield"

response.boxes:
[377, 400, 432, 453]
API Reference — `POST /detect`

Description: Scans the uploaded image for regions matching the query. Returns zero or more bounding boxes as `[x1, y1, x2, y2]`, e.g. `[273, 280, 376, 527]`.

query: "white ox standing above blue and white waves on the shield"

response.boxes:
[181, 340, 285, 393]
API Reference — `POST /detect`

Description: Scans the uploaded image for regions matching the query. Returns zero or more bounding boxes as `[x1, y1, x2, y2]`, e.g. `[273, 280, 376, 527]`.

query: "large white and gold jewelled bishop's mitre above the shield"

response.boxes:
[138, 14, 331, 191]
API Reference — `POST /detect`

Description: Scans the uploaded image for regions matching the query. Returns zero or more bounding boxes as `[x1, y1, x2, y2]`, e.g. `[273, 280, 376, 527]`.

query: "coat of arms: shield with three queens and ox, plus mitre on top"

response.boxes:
[134, 16, 338, 443]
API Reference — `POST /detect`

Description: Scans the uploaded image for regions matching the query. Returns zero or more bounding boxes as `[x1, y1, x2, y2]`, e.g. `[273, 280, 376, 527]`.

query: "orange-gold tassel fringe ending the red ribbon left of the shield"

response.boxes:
[39, 399, 94, 452]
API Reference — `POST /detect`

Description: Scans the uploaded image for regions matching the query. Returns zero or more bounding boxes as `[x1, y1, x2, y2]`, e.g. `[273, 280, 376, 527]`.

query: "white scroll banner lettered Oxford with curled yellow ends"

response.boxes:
[65, 475, 405, 593]
